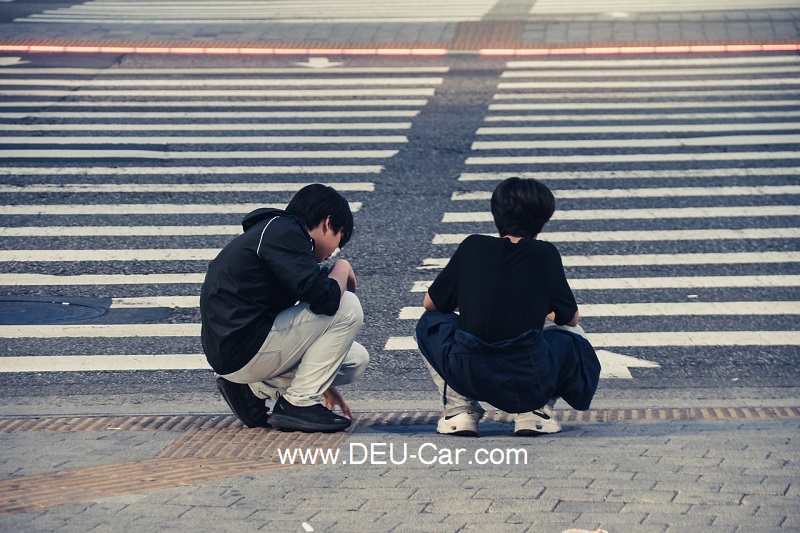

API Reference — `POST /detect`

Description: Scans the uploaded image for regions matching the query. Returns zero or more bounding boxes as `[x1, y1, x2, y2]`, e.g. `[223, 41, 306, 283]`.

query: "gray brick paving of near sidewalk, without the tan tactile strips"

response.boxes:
[0, 410, 800, 532]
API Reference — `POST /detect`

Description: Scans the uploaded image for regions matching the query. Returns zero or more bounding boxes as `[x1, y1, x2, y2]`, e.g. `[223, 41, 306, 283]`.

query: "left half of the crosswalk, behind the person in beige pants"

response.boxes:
[0, 62, 448, 372]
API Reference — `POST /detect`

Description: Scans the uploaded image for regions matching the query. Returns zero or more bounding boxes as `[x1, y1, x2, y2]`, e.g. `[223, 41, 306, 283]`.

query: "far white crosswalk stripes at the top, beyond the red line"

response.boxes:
[15, 0, 797, 24]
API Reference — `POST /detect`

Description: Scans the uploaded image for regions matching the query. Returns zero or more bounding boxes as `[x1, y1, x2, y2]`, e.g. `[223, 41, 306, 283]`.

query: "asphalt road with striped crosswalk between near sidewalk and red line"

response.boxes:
[0, 50, 800, 414]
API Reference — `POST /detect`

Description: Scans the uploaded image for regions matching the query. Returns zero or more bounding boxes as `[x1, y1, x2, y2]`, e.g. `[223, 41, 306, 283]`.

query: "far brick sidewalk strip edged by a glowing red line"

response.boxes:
[0, 6, 800, 53]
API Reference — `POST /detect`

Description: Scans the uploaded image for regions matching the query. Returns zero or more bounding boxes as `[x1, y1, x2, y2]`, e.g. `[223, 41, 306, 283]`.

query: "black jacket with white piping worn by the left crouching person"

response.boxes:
[200, 208, 341, 375]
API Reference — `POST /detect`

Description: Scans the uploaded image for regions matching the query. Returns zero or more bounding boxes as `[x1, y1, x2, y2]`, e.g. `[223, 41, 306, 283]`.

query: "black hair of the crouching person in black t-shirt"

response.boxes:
[492, 177, 556, 239]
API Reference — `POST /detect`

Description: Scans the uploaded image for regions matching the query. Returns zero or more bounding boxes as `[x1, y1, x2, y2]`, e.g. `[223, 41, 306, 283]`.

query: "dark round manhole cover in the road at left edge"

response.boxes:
[0, 297, 106, 326]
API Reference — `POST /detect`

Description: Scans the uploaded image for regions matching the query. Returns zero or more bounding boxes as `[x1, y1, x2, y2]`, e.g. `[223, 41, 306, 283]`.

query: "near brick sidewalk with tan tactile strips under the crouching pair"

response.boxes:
[0, 407, 800, 532]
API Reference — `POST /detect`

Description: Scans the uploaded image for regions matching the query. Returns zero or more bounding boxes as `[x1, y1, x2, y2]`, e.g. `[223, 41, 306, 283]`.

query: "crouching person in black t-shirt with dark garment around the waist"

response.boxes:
[416, 178, 600, 436]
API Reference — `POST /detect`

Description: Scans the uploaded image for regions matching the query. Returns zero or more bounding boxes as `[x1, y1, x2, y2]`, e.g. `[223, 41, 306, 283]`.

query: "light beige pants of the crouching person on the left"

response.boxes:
[222, 292, 369, 407]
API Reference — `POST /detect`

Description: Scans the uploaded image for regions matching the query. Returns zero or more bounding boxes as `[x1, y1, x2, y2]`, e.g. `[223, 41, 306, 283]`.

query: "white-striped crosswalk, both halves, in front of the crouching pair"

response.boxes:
[0, 55, 800, 378]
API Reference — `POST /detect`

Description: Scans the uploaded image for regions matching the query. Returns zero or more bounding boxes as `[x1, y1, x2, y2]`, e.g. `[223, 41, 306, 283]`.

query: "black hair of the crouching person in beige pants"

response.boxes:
[286, 183, 353, 248]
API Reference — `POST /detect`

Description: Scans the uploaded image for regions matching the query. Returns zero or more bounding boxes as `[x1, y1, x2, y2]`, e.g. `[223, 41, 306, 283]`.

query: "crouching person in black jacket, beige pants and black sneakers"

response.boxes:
[200, 184, 369, 432]
